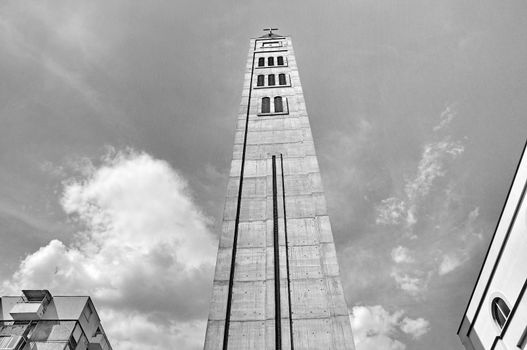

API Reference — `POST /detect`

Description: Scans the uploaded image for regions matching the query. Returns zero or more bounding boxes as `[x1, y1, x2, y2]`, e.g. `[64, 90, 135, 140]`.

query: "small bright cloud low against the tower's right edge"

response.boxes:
[350, 305, 430, 350]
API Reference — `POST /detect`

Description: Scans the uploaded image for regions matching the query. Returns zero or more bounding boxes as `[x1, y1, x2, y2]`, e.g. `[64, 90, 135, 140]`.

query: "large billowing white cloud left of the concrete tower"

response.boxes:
[3, 151, 216, 350]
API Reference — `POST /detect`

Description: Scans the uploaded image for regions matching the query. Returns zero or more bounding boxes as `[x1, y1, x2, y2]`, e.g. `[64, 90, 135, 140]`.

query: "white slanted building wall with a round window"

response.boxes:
[458, 141, 527, 350]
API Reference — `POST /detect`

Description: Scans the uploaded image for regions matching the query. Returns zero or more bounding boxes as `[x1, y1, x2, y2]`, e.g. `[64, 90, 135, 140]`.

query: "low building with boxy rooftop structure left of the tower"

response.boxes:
[0, 290, 112, 350]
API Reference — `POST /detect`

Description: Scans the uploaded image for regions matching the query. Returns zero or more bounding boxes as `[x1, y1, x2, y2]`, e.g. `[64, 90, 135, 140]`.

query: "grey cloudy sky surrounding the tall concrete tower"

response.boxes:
[0, 0, 527, 350]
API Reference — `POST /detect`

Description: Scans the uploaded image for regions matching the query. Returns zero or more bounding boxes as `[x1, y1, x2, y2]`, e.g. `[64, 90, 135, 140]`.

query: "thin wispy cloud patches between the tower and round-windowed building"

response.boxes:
[376, 105, 470, 297]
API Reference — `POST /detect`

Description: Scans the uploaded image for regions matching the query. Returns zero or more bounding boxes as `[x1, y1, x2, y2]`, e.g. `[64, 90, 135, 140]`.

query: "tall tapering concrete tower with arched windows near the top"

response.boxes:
[204, 32, 354, 350]
